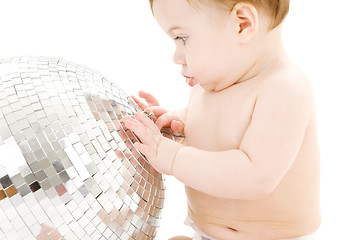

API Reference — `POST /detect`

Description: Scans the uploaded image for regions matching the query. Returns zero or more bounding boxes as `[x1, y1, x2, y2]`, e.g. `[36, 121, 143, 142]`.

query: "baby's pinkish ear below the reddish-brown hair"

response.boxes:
[230, 2, 259, 43]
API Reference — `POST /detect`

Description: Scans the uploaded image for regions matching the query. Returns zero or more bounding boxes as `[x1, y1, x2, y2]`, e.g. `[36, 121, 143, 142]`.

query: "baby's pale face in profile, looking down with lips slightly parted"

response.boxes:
[153, 0, 244, 91]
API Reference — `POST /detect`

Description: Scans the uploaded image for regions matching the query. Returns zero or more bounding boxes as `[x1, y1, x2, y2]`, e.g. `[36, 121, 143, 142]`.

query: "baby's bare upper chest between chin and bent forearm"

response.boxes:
[185, 86, 256, 151]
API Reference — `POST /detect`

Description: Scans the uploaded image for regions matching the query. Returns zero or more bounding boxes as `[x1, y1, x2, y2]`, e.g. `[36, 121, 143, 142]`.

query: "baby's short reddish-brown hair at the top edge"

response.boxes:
[149, 0, 289, 29]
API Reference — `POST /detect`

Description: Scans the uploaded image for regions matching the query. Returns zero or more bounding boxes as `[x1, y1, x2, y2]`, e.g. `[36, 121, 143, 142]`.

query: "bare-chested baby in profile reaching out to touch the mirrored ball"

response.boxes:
[124, 0, 320, 240]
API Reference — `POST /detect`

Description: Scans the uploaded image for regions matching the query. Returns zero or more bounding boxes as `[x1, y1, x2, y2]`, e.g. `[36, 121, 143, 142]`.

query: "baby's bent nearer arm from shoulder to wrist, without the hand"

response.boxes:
[172, 79, 313, 199]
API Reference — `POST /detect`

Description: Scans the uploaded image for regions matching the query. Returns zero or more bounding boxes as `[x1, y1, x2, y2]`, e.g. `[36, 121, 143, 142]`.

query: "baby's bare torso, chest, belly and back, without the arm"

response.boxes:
[185, 58, 320, 240]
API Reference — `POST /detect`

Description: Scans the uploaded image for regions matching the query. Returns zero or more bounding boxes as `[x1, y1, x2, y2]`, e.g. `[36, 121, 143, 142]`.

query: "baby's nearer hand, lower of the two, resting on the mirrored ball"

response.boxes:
[123, 112, 181, 175]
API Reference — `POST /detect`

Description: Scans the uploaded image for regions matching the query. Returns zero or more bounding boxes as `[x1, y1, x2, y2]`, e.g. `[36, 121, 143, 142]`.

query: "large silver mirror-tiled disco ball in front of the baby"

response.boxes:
[0, 57, 164, 240]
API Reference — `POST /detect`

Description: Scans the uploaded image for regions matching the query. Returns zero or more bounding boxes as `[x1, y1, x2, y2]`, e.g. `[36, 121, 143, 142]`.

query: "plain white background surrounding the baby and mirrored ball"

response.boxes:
[0, 0, 340, 240]
